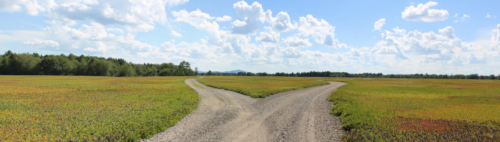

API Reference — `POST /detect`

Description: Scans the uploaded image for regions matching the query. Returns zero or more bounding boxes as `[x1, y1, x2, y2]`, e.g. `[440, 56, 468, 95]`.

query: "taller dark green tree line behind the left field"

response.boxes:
[0, 50, 197, 77]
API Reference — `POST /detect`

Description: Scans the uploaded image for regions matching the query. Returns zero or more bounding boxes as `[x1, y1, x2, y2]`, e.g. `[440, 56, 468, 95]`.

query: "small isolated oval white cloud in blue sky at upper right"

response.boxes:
[401, 1, 449, 22]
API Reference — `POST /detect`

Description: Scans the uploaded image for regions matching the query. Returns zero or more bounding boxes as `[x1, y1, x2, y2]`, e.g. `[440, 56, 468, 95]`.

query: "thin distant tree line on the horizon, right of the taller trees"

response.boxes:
[200, 71, 500, 80]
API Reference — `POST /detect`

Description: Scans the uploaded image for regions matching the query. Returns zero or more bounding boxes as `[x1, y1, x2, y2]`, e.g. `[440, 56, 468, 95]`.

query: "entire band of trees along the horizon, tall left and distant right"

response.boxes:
[0, 50, 500, 79]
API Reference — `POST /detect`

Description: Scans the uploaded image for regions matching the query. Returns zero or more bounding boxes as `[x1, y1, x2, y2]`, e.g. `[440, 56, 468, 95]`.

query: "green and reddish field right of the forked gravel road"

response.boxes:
[329, 78, 500, 141]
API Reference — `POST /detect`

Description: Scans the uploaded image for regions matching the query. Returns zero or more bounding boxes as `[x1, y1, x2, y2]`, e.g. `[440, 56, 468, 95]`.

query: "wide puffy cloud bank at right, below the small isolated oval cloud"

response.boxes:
[370, 26, 487, 66]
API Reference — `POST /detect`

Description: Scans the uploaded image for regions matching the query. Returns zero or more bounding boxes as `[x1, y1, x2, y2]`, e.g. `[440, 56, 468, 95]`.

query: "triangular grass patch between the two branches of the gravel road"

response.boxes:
[196, 76, 328, 98]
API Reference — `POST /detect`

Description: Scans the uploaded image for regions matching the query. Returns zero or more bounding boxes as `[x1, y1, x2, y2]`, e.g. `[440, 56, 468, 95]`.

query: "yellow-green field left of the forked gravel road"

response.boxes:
[0, 76, 198, 141]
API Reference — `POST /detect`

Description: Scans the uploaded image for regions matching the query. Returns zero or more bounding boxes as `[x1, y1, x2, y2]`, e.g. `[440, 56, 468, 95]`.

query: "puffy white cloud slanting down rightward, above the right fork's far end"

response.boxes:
[298, 15, 347, 48]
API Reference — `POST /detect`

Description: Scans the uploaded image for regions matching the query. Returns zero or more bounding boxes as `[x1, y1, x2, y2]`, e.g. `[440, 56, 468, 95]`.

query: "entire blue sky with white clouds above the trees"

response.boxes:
[0, 0, 500, 75]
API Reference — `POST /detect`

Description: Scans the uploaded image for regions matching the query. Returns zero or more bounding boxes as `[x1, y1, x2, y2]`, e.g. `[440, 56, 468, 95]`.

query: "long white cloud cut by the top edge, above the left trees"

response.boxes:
[36, 0, 188, 32]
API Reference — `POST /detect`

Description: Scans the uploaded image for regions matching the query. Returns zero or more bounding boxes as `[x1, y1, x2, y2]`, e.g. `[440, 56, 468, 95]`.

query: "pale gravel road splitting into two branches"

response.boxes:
[142, 79, 345, 142]
